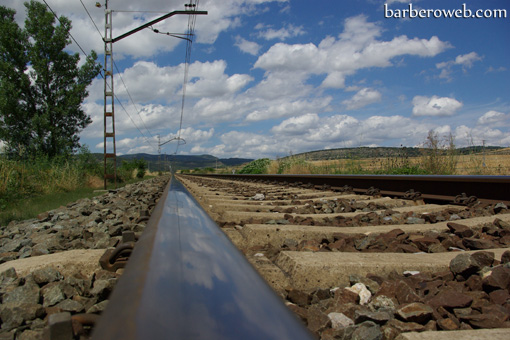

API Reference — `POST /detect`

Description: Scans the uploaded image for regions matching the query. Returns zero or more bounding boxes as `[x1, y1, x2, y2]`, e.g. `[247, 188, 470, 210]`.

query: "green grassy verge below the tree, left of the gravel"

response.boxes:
[0, 149, 155, 225]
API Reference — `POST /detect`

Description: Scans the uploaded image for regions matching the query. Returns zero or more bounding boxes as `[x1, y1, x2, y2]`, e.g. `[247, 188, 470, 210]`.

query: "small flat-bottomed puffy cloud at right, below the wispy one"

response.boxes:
[413, 96, 462, 117]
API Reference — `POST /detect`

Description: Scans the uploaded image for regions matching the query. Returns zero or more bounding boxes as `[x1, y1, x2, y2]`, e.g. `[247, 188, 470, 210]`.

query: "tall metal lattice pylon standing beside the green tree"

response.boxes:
[104, 1, 117, 189]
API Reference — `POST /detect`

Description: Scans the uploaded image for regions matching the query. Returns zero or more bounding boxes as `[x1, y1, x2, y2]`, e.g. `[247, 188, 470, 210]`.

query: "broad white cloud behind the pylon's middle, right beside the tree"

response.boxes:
[82, 60, 253, 132]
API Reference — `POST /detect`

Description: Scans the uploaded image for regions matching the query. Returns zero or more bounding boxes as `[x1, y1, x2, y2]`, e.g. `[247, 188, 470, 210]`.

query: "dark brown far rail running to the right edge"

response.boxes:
[192, 174, 510, 205]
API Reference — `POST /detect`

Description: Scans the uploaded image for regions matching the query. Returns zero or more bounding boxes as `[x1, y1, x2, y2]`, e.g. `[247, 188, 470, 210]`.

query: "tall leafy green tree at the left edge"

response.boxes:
[0, 0, 101, 158]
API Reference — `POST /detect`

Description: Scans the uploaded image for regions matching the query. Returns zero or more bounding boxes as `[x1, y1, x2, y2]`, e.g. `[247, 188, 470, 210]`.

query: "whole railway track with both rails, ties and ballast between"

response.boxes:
[91, 176, 510, 339]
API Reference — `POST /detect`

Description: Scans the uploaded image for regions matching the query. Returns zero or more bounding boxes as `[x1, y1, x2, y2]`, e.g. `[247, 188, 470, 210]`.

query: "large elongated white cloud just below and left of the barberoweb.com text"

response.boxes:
[254, 15, 450, 88]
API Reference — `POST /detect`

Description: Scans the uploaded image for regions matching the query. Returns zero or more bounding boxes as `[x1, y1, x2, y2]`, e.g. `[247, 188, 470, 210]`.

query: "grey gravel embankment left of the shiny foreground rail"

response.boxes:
[0, 177, 169, 339]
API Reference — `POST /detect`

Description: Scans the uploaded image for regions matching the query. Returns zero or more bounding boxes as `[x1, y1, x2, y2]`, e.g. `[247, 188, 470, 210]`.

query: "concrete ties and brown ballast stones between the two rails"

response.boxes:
[179, 176, 510, 339]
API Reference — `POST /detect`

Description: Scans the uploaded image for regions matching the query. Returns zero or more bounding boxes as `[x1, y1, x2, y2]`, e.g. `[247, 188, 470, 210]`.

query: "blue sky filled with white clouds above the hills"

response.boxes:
[6, 0, 510, 158]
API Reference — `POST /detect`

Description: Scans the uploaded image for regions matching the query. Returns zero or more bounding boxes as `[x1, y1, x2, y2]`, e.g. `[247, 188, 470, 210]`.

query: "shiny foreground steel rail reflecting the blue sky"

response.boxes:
[92, 177, 312, 340]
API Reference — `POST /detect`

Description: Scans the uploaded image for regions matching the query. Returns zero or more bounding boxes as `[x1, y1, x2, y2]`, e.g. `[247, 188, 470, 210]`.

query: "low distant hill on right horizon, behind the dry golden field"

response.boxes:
[283, 146, 508, 161]
